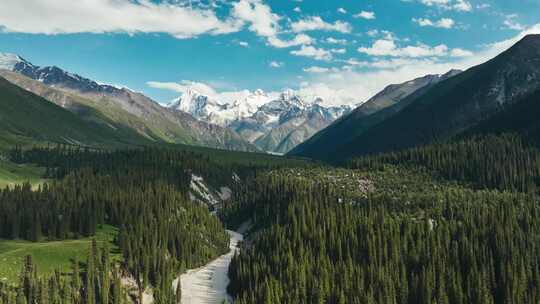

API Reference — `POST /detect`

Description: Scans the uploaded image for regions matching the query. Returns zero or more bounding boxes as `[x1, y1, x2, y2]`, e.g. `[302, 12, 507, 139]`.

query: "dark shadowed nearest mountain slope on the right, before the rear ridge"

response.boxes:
[297, 35, 540, 163]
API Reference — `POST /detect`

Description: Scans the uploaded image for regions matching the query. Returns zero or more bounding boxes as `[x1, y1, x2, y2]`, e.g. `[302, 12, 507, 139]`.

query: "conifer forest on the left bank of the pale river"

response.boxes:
[0, 145, 309, 304]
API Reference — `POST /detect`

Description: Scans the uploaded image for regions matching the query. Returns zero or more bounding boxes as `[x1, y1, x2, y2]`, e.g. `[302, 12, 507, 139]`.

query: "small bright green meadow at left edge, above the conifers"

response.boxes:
[0, 160, 45, 188]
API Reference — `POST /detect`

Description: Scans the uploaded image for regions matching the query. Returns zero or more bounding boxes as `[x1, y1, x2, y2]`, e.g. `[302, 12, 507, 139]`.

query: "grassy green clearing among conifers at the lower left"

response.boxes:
[0, 225, 120, 284]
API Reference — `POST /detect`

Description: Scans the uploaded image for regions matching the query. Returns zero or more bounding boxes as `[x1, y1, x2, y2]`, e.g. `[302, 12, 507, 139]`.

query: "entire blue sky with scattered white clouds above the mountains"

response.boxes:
[0, 0, 540, 104]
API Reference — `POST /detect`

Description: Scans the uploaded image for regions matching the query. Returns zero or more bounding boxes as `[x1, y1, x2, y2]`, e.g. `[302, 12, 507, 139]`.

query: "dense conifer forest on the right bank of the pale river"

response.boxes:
[226, 166, 540, 304]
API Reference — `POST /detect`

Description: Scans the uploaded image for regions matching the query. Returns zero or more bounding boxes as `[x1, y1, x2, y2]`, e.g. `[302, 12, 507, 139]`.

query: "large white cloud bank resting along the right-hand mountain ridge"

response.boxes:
[299, 23, 540, 105]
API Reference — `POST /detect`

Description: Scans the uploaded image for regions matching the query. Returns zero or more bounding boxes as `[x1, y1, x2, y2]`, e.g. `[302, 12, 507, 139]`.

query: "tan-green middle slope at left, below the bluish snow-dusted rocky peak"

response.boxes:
[0, 70, 256, 151]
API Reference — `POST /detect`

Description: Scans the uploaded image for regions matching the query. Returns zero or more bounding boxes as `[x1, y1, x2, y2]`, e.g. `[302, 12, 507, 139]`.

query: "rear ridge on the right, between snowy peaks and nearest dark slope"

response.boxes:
[291, 70, 461, 159]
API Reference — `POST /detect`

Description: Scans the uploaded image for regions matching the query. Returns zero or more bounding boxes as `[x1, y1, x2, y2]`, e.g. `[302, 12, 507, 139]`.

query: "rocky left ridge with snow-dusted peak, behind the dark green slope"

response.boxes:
[0, 54, 257, 151]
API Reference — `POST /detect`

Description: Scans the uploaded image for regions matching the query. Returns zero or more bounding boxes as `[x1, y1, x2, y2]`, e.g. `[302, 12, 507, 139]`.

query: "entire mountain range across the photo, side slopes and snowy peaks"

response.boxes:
[0, 35, 540, 161]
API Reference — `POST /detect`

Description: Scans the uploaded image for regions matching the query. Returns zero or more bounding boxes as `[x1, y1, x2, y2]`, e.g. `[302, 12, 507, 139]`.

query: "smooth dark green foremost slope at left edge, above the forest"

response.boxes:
[0, 77, 152, 149]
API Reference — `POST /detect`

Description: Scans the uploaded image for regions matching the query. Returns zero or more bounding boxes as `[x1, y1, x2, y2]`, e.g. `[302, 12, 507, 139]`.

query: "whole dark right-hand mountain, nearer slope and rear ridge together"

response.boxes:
[290, 35, 540, 161]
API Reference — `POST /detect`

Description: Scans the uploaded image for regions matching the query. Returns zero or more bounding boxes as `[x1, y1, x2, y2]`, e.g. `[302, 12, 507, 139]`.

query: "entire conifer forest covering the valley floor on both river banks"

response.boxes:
[0, 134, 540, 304]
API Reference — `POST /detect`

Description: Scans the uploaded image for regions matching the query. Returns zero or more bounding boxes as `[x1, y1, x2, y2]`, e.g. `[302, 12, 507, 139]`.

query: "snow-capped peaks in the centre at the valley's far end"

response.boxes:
[169, 88, 352, 153]
